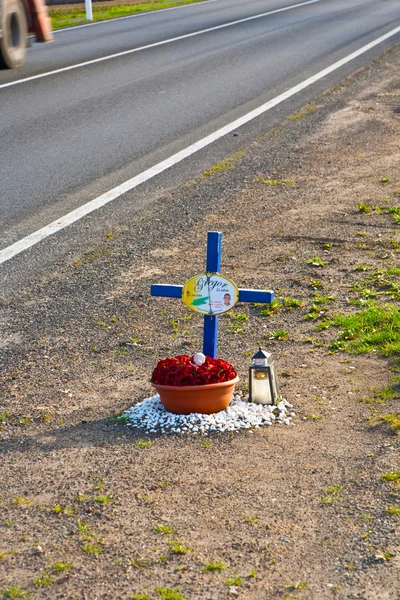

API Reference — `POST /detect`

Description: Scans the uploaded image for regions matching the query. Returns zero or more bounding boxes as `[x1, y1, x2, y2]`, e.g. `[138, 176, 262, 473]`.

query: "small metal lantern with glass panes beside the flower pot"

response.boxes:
[249, 348, 280, 404]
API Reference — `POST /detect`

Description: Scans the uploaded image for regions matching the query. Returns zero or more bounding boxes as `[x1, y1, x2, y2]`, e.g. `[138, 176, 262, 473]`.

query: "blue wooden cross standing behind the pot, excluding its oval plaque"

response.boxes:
[151, 231, 274, 358]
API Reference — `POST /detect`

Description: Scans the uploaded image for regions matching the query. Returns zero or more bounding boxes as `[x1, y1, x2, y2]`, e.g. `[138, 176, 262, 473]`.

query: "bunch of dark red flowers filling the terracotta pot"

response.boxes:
[151, 354, 237, 385]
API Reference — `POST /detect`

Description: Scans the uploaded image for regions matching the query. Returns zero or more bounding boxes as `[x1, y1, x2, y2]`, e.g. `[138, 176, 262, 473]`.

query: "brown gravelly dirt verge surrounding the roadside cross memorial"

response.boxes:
[0, 47, 400, 600]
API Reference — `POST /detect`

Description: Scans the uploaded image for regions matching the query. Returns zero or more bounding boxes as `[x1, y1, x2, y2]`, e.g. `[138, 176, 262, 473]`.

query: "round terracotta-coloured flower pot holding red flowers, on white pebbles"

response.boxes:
[153, 377, 239, 415]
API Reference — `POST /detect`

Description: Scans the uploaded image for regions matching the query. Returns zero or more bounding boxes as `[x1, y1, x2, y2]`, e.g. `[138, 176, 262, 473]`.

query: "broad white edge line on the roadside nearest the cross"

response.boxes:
[0, 27, 400, 264]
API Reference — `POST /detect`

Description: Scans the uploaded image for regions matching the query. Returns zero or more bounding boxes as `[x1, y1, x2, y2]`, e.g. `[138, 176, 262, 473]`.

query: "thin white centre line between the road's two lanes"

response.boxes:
[0, 0, 321, 90]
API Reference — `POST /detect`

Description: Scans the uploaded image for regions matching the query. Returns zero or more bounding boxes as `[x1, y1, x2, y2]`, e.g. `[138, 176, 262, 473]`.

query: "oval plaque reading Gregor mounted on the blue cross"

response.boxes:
[182, 273, 239, 315]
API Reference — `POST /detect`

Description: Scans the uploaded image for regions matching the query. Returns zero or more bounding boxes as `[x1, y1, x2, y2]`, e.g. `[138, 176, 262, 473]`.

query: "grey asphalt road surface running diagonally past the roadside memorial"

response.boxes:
[0, 0, 400, 277]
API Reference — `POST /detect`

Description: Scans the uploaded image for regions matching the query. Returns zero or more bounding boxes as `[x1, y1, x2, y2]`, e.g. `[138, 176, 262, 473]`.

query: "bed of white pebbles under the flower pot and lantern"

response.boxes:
[122, 394, 295, 434]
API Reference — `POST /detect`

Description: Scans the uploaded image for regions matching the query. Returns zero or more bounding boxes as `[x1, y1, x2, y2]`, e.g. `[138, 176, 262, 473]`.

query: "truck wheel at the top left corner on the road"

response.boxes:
[0, 0, 28, 69]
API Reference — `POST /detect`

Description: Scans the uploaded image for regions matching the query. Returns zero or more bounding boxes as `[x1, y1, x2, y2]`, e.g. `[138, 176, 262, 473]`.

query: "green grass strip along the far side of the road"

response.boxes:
[49, 0, 206, 29]
